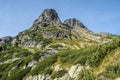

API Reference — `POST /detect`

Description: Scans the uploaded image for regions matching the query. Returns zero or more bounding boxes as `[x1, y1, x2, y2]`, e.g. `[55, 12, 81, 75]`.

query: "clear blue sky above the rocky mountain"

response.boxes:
[0, 0, 120, 37]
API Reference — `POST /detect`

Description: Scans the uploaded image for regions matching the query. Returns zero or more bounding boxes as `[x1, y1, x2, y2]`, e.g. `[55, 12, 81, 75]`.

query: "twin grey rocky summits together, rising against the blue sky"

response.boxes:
[32, 9, 87, 29]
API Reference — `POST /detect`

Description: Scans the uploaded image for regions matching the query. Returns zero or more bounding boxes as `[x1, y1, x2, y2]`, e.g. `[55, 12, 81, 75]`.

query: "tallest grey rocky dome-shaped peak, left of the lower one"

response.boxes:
[34, 9, 61, 27]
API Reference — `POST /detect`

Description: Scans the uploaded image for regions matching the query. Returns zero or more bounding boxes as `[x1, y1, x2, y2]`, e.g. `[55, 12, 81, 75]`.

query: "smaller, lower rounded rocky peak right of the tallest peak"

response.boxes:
[64, 18, 87, 29]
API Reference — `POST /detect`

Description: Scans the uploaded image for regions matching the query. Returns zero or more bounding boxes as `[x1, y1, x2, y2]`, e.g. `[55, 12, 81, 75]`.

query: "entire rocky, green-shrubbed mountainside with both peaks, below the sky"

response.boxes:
[0, 9, 120, 80]
